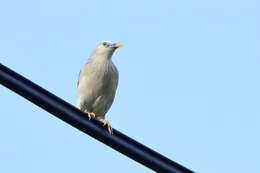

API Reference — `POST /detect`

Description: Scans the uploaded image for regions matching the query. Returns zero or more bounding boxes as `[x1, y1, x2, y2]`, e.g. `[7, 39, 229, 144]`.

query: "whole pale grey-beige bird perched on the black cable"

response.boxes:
[77, 41, 122, 135]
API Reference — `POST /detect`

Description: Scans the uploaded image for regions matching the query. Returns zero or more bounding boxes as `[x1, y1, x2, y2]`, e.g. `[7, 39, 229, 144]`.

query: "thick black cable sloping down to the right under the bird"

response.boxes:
[0, 63, 193, 173]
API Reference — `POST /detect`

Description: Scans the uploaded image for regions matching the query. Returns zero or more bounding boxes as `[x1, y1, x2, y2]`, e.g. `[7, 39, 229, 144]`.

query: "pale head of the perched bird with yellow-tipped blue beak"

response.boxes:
[92, 40, 123, 59]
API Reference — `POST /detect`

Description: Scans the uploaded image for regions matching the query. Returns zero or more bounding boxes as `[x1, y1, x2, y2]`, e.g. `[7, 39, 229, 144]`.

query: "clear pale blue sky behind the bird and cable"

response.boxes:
[0, 0, 260, 173]
